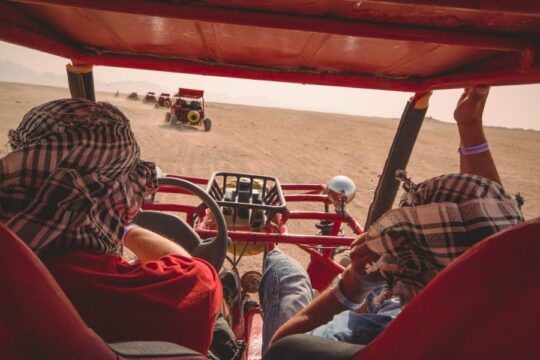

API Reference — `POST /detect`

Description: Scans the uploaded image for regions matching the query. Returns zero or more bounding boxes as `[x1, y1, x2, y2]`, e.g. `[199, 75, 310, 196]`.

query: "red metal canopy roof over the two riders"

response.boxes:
[0, 0, 540, 91]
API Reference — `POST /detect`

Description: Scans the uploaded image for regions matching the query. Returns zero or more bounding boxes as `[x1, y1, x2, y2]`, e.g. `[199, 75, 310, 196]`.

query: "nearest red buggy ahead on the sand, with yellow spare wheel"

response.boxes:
[165, 88, 212, 131]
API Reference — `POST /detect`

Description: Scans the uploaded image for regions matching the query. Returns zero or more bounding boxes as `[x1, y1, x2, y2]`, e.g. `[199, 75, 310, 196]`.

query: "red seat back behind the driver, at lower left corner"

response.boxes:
[0, 223, 116, 360]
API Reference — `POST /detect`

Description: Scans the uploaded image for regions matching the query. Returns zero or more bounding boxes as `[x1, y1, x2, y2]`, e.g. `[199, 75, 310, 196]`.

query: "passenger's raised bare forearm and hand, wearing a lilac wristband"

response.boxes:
[454, 86, 502, 185]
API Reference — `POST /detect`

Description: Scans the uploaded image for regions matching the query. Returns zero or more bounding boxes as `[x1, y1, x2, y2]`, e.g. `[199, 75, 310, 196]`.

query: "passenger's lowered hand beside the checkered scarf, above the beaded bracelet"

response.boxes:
[341, 233, 382, 303]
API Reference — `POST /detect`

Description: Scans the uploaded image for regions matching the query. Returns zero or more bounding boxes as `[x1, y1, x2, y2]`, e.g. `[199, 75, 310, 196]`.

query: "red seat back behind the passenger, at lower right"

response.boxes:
[355, 218, 540, 360]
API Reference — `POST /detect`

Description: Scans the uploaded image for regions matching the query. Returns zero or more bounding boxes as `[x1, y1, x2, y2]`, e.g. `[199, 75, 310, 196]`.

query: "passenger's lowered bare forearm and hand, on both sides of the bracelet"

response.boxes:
[271, 235, 379, 343]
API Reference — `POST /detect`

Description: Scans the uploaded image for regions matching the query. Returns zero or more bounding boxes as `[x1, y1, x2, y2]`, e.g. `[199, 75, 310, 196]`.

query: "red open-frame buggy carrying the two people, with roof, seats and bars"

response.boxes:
[0, 0, 540, 360]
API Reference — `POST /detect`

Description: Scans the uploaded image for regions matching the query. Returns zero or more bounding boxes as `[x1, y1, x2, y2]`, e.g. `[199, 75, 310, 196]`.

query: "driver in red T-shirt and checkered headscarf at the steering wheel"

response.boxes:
[0, 99, 222, 354]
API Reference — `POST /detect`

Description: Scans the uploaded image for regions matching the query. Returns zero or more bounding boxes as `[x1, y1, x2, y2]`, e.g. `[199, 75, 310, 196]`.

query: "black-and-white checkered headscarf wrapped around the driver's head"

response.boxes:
[0, 99, 157, 253]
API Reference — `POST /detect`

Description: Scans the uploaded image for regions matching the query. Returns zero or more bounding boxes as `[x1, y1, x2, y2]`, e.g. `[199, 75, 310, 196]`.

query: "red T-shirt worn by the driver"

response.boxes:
[42, 251, 222, 354]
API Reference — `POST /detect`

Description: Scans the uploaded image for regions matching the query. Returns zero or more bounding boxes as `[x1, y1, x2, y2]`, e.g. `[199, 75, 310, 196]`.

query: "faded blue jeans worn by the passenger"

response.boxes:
[259, 248, 401, 354]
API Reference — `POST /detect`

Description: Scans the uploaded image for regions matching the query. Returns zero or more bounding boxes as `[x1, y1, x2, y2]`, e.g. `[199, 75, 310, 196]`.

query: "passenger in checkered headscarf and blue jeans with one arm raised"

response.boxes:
[259, 86, 523, 354]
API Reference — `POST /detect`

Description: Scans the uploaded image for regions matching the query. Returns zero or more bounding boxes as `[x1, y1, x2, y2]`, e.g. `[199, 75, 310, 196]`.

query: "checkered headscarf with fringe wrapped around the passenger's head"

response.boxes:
[366, 174, 523, 303]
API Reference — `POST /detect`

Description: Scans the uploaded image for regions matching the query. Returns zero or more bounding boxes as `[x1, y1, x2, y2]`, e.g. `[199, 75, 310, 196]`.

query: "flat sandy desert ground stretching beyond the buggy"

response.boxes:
[0, 83, 540, 269]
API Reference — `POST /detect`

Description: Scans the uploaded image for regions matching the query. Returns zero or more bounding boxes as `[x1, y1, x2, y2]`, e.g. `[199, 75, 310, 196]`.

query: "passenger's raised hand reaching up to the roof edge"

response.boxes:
[454, 86, 489, 128]
